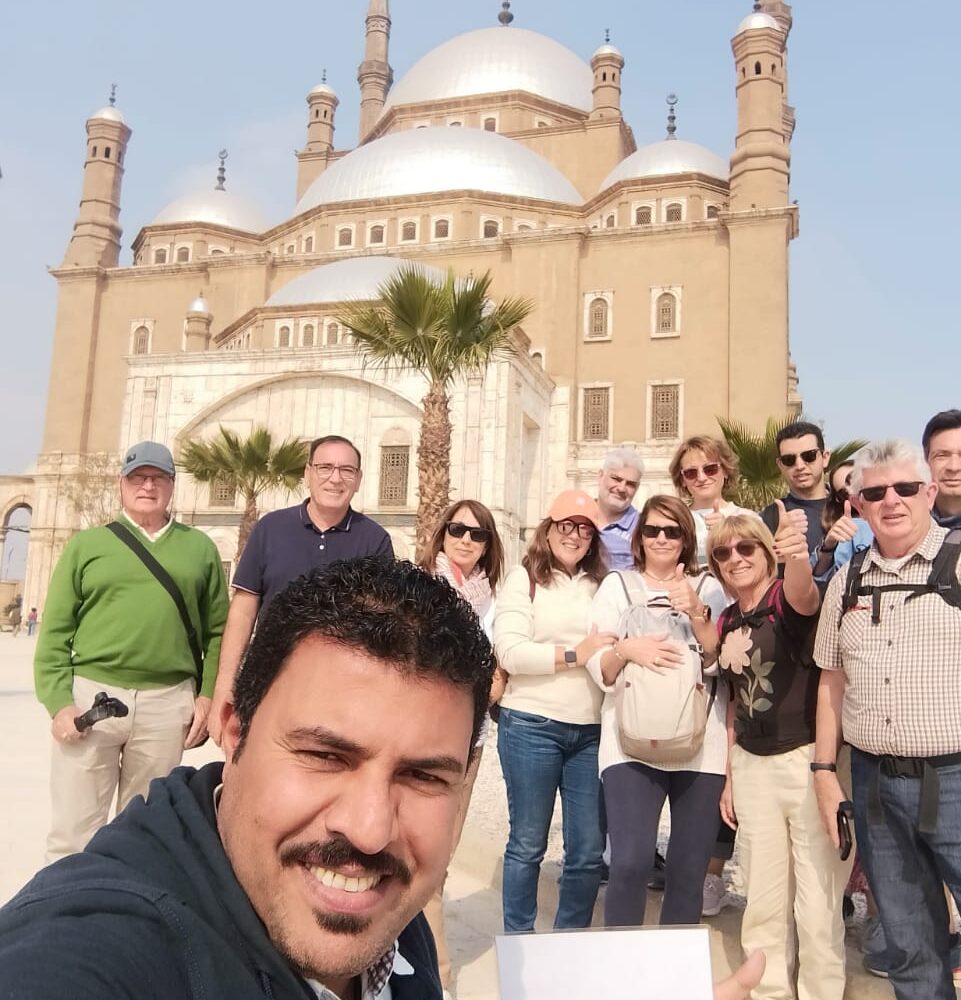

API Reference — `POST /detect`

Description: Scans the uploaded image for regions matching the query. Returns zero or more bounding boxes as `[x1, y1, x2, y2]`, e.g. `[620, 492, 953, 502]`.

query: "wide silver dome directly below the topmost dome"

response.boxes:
[296, 124, 584, 215]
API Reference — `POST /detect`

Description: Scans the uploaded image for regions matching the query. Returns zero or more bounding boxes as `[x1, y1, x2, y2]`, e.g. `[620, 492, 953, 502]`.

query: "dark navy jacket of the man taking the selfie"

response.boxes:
[0, 764, 441, 1000]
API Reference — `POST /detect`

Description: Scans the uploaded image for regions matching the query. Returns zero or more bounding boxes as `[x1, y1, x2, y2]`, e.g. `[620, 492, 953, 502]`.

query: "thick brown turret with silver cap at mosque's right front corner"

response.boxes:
[731, 3, 793, 212]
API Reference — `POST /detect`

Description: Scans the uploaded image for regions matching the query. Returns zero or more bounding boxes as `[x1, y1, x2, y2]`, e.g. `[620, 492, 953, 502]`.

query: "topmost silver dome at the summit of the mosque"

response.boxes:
[384, 27, 594, 111]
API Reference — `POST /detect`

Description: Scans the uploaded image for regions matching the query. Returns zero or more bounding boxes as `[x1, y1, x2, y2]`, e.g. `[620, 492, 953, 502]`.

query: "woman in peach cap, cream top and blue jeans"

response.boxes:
[494, 490, 614, 931]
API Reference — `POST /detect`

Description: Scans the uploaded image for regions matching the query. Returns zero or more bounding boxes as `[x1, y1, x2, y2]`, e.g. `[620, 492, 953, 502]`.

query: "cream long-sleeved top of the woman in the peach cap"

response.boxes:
[494, 566, 603, 725]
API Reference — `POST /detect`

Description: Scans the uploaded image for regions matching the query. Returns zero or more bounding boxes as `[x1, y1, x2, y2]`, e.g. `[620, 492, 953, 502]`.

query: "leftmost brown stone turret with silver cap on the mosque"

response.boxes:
[63, 86, 131, 267]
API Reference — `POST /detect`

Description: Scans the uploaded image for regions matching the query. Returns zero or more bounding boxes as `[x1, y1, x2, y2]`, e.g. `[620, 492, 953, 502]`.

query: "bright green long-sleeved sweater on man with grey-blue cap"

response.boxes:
[33, 521, 227, 716]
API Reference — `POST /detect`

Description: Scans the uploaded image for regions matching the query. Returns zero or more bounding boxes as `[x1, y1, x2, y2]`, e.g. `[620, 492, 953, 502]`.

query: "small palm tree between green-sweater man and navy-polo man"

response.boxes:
[178, 426, 308, 559]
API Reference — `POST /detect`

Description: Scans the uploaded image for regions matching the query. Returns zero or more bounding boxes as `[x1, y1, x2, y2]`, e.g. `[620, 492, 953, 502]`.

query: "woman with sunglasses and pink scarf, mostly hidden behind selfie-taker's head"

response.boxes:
[420, 500, 504, 990]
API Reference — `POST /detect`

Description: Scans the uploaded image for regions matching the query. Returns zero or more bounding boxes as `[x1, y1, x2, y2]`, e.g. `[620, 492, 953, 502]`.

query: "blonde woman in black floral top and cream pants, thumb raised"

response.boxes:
[708, 512, 852, 1000]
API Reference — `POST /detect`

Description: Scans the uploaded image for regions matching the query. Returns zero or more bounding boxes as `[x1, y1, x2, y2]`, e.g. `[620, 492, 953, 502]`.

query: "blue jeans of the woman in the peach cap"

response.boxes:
[497, 708, 604, 931]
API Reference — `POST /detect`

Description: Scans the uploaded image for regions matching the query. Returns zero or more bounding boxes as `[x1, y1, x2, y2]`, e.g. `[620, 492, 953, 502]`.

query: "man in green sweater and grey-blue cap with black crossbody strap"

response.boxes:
[34, 441, 227, 861]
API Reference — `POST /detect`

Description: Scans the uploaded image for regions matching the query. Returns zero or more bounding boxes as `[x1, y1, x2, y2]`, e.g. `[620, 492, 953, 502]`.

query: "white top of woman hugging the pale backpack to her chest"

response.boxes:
[587, 569, 730, 774]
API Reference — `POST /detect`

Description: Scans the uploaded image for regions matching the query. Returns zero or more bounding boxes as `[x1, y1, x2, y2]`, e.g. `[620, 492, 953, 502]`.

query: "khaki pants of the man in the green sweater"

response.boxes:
[47, 677, 194, 862]
